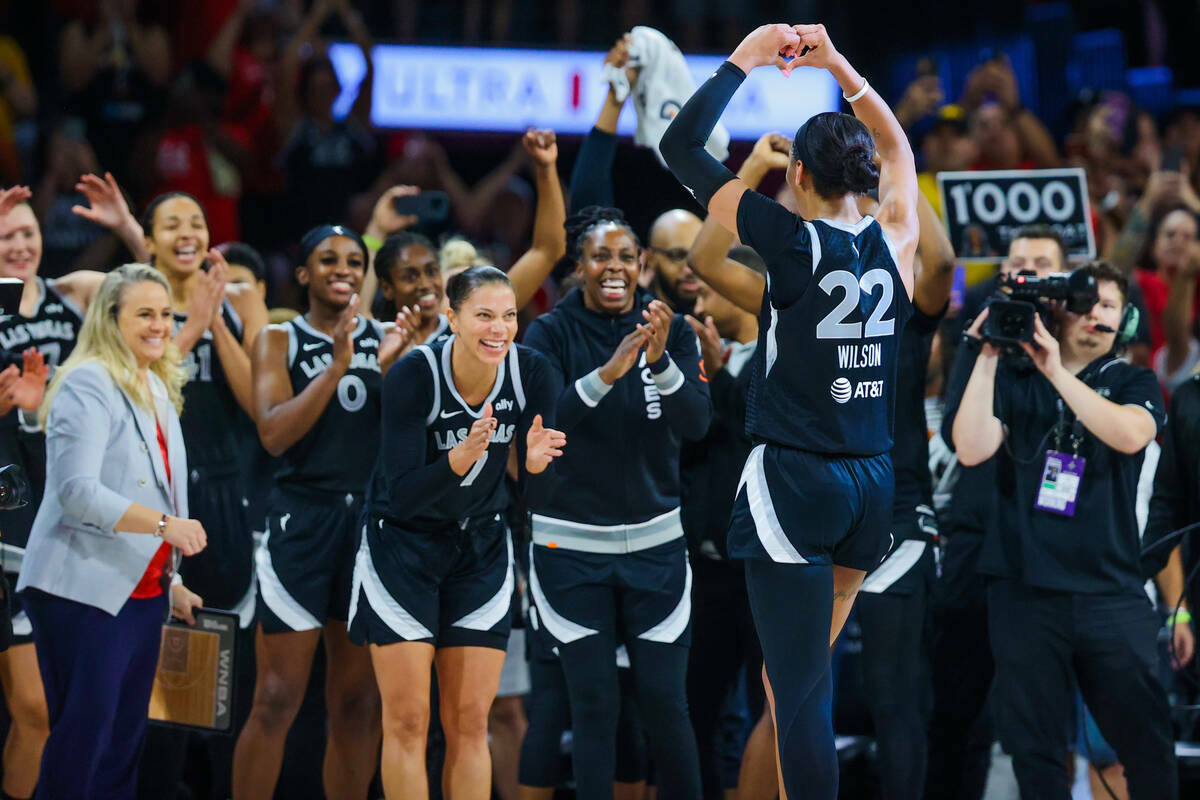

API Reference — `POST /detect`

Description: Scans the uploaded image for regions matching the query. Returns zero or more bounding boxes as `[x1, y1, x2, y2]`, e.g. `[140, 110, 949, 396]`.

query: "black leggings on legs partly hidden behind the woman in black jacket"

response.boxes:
[518, 657, 647, 787]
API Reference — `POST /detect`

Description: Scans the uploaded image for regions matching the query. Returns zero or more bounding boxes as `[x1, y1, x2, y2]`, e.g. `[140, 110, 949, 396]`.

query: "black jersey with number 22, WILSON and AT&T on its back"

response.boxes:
[738, 192, 912, 456]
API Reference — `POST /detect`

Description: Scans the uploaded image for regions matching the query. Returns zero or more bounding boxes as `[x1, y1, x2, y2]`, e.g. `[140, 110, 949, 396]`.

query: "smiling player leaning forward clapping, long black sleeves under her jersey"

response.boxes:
[350, 266, 566, 800]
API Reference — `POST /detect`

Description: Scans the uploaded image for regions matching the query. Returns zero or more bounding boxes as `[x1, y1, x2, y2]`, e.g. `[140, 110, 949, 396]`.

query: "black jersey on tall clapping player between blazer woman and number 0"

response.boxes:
[174, 300, 242, 474]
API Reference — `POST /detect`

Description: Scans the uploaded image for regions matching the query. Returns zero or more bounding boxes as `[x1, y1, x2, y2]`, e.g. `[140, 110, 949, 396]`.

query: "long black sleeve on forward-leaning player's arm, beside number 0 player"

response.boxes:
[382, 353, 462, 518]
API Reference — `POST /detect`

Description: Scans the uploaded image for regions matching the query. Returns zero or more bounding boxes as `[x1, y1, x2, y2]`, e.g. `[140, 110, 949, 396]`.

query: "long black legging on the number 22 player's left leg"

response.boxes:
[745, 559, 838, 800]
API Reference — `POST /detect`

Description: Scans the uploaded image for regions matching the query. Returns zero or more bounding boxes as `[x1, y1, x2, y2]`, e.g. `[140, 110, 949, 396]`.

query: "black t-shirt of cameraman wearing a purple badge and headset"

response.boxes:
[979, 356, 1166, 594]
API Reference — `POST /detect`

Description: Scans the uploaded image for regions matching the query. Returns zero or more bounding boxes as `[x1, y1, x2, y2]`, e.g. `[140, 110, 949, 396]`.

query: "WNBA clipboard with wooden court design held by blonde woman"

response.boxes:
[149, 608, 238, 733]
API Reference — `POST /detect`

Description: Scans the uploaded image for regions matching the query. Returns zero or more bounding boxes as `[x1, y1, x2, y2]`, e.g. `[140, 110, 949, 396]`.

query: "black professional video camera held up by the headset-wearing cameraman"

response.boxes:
[983, 270, 1099, 348]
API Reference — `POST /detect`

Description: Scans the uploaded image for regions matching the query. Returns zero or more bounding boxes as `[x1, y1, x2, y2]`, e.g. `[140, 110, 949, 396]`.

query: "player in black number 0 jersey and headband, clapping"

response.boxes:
[233, 225, 388, 800]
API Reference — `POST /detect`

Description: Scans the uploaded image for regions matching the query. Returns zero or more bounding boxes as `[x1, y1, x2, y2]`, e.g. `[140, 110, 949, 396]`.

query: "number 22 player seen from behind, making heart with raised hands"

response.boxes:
[661, 24, 918, 800]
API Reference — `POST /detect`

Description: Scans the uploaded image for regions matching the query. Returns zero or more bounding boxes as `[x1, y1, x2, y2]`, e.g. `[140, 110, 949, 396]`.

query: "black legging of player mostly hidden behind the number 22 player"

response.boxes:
[856, 583, 931, 800]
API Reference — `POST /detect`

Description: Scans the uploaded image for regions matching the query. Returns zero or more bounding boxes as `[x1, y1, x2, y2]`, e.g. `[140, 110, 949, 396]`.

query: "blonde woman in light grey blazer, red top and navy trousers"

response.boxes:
[17, 264, 206, 800]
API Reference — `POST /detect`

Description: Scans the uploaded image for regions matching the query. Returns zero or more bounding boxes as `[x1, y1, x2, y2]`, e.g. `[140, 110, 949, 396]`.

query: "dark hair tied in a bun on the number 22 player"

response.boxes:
[792, 112, 880, 198]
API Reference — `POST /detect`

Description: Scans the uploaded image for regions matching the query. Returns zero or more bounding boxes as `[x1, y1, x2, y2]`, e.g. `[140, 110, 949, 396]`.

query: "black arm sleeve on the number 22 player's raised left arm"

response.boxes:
[659, 61, 746, 209]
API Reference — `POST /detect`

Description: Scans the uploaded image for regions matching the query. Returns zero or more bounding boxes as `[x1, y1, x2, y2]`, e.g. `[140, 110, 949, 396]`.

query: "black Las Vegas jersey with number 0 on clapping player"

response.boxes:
[276, 317, 384, 493]
